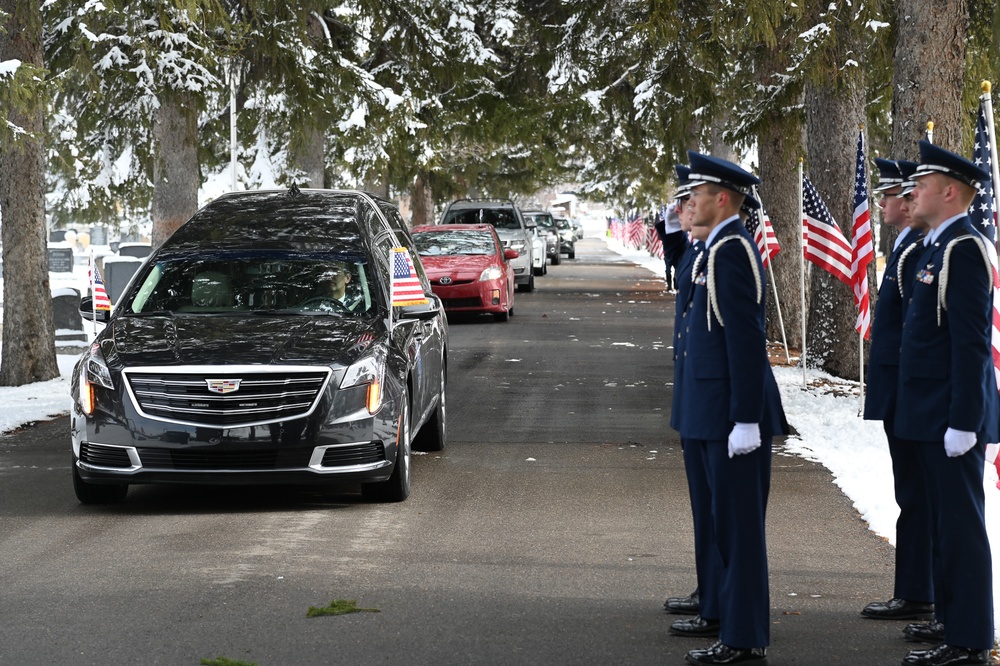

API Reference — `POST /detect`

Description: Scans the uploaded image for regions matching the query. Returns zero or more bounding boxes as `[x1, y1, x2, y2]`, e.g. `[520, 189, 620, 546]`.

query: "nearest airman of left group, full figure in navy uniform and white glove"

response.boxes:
[671, 151, 787, 664]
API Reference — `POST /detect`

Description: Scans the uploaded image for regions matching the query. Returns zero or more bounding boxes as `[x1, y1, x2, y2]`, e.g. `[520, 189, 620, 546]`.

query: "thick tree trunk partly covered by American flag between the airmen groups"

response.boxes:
[806, 85, 871, 380]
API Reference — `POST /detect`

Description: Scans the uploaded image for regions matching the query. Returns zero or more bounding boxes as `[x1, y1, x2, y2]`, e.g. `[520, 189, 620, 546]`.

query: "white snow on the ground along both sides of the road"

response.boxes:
[0, 223, 1000, 640]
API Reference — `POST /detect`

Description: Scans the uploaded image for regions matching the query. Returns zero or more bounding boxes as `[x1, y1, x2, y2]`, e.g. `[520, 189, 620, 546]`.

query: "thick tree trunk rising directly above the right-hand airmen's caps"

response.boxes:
[892, 0, 969, 154]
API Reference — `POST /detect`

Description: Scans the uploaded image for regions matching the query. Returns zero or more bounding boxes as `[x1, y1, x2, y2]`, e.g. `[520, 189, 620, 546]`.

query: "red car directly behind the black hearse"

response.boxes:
[412, 224, 518, 321]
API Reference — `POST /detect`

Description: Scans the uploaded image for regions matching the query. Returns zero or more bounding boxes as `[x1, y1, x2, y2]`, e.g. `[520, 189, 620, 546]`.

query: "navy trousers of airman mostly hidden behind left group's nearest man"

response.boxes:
[681, 439, 722, 620]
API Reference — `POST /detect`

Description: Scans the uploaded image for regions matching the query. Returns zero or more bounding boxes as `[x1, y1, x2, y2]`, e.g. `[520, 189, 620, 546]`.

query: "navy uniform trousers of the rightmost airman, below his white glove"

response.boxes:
[911, 438, 993, 650]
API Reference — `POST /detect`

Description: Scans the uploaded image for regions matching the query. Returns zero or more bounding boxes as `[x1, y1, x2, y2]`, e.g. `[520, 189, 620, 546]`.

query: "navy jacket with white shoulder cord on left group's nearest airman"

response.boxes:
[671, 219, 788, 441]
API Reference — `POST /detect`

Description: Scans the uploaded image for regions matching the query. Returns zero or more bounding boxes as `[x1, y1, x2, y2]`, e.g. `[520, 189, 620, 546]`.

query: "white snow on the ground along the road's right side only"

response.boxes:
[608, 230, 1000, 641]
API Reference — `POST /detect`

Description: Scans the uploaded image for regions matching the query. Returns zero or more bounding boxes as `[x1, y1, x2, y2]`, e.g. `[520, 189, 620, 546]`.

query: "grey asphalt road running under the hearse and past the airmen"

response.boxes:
[0, 239, 918, 666]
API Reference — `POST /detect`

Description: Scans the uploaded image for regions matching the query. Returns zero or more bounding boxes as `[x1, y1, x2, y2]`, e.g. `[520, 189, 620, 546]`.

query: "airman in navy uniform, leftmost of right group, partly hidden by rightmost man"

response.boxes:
[861, 158, 934, 620]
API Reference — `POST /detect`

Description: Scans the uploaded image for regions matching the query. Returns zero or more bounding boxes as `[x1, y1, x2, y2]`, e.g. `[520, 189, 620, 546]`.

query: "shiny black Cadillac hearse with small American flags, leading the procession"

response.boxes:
[76, 186, 448, 503]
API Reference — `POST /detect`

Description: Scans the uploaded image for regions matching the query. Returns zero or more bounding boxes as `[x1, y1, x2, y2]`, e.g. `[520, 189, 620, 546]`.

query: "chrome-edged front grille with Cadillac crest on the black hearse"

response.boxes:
[125, 368, 330, 428]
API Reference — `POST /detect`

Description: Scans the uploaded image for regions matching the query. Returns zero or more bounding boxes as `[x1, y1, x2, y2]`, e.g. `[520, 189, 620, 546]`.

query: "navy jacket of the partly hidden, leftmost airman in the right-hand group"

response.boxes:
[865, 231, 924, 421]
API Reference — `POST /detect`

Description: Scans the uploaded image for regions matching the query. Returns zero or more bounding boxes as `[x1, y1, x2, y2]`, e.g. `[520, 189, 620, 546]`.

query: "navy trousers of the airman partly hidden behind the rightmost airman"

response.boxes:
[883, 418, 941, 608]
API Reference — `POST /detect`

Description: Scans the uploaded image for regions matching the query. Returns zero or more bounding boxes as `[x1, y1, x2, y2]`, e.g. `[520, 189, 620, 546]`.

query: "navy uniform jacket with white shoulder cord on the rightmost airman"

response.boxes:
[895, 217, 1000, 442]
